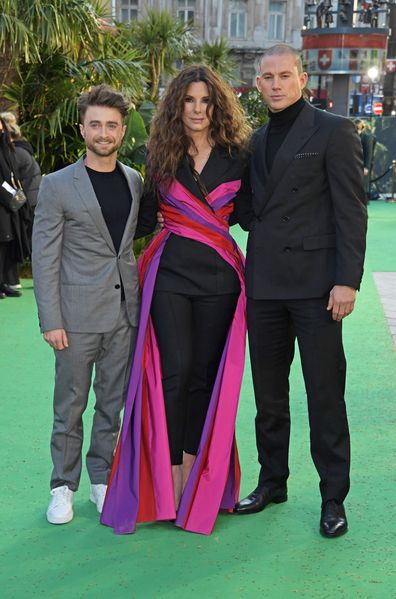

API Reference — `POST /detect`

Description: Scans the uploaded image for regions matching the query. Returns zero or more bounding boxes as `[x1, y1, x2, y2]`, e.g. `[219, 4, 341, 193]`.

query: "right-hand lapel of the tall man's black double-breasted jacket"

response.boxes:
[262, 104, 319, 209]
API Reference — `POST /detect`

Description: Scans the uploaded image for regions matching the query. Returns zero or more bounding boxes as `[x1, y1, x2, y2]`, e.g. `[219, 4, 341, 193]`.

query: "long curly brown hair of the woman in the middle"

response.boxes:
[145, 65, 251, 191]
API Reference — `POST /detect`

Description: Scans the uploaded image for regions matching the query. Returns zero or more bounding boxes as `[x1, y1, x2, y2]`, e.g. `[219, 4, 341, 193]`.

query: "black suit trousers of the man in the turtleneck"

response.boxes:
[247, 297, 350, 502]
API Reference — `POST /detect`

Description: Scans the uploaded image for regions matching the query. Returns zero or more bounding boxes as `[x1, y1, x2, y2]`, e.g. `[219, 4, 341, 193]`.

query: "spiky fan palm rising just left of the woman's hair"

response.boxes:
[123, 9, 195, 103]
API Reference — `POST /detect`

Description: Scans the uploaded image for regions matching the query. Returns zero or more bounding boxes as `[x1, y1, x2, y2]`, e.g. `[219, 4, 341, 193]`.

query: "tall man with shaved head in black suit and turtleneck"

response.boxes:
[235, 44, 367, 537]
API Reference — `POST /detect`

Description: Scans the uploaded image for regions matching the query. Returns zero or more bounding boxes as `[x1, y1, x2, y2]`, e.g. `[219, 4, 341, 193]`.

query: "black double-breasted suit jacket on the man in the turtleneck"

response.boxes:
[238, 104, 367, 299]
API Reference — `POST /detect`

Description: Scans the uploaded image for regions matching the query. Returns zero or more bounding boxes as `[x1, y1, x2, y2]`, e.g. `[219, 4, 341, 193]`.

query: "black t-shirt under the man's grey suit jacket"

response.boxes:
[85, 165, 132, 253]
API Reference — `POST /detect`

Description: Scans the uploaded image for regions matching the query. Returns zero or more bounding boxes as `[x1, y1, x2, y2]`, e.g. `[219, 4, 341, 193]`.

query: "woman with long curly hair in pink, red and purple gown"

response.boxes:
[101, 66, 250, 534]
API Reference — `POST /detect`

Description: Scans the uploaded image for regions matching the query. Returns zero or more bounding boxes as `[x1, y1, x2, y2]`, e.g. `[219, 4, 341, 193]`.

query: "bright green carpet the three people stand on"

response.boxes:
[0, 202, 396, 599]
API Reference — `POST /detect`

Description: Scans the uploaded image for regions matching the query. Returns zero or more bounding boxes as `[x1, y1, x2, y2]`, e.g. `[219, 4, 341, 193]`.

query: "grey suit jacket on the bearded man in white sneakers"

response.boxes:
[32, 158, 142, 333]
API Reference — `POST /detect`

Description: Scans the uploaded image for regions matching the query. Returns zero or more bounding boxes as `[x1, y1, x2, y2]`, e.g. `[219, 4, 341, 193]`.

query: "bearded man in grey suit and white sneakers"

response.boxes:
[33, 85, 142, 524]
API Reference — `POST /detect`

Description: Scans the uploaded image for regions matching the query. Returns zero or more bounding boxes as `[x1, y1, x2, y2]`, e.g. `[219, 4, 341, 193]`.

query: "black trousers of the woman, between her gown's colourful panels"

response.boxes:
[151, 291, 239, 465]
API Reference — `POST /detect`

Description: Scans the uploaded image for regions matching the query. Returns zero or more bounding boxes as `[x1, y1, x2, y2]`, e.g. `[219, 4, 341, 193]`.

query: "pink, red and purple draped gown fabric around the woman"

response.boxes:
[101, 168, 246, 534]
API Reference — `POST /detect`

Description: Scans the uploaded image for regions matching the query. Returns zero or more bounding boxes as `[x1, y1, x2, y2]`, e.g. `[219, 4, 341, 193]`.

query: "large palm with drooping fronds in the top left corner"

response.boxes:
[0, 0, 146, 172]
